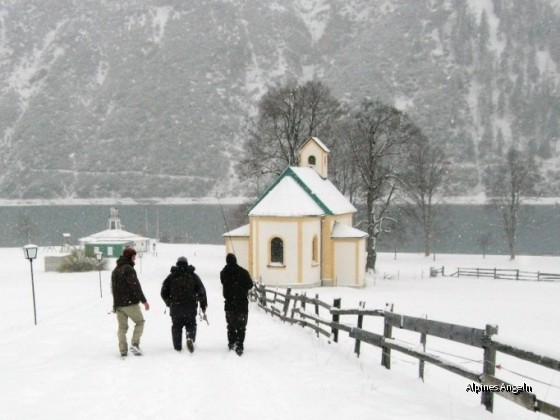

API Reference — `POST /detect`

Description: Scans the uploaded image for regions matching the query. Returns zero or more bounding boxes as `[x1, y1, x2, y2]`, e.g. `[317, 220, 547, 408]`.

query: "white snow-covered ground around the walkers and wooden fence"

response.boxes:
[0, 244, 560, 420]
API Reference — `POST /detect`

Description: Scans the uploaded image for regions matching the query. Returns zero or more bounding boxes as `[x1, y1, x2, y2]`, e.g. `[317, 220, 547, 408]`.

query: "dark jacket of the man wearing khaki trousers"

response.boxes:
[111, 256, 146, 309]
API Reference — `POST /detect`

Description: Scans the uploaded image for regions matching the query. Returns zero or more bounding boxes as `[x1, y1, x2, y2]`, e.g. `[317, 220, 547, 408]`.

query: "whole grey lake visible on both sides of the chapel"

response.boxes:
[0, 204, 560, 255]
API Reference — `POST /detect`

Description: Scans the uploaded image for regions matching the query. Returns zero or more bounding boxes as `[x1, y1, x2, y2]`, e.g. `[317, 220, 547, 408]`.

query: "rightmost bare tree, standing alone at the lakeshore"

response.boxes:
[488, 147, 538, 260]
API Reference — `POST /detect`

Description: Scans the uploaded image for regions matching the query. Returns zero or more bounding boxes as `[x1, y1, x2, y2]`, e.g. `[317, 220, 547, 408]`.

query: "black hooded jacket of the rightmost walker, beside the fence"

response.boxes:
[220, 261, 253, 312]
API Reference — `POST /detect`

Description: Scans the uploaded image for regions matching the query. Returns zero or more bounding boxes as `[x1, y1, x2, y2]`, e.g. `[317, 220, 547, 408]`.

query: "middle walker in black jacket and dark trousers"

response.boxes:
[161, 257, 208, 353]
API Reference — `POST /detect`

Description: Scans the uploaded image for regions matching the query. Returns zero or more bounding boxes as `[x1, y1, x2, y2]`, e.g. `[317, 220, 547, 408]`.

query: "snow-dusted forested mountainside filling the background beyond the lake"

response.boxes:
[0, 0, 560, 199]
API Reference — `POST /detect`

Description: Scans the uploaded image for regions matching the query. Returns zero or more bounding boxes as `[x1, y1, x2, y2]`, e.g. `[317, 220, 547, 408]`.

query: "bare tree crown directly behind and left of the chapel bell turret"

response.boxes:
[236, 81, 342, 193]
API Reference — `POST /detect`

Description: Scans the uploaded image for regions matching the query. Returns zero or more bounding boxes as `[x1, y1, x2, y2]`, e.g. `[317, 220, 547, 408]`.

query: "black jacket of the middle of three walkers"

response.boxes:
[161, 263, 208, 316]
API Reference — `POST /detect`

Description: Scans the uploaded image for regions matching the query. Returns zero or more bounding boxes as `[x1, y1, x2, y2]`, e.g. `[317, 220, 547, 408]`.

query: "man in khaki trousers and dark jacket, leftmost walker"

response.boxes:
[111, 247, 150, 357]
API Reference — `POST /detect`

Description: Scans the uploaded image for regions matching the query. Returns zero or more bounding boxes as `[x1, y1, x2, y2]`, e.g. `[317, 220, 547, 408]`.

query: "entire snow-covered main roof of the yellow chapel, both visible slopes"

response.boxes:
[249, 166, 356, 217]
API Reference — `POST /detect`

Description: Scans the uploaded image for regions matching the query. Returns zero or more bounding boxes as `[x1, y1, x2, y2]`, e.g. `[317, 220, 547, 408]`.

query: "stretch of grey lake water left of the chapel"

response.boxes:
[0, 204, 237, 247]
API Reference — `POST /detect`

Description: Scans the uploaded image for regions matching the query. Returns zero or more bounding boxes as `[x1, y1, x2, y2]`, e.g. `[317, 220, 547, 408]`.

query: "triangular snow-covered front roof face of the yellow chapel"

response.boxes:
[249, 176, 326, 217]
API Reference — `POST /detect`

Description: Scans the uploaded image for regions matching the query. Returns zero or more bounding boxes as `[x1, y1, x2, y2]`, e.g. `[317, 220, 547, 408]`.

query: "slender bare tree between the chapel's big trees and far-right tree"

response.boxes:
[405, 138, 448, 256]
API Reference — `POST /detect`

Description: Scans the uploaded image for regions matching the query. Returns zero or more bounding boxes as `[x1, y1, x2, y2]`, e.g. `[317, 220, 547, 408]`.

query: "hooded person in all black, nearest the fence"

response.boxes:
[220, 254, 253, 356]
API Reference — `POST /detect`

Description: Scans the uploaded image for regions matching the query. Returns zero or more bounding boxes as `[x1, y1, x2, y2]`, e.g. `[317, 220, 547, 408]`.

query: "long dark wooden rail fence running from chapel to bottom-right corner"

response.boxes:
[251, 284, 560, 419]
